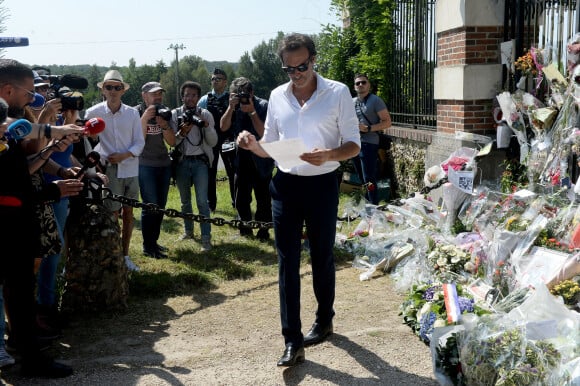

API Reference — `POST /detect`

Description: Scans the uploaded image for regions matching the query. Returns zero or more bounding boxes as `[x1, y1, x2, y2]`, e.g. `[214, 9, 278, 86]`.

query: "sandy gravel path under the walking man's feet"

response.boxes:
[2, 266, 437, 386]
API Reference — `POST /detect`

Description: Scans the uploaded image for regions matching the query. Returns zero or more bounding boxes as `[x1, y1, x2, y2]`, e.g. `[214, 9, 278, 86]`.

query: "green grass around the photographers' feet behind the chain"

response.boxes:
[129, 172, 358, 297]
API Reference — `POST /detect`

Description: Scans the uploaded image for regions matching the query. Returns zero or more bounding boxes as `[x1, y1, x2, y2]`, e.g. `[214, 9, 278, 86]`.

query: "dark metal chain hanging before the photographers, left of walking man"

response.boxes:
[102, 187, 274, 230]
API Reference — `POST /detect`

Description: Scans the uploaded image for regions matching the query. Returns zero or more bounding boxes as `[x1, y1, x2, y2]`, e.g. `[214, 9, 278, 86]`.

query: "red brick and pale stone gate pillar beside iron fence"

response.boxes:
[435, 0, 503, 135]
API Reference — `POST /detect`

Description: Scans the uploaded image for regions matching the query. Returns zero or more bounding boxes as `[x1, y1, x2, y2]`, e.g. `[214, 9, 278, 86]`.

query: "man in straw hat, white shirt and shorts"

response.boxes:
[85, 70, 145, 270]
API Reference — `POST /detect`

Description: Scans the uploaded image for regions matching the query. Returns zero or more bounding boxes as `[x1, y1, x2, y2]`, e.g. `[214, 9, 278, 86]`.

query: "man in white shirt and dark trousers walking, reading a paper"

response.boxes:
[237, 34, 360, 366]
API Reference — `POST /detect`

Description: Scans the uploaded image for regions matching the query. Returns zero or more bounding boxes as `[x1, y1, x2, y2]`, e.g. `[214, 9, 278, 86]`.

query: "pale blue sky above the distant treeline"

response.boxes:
[0, 0, 338, 66]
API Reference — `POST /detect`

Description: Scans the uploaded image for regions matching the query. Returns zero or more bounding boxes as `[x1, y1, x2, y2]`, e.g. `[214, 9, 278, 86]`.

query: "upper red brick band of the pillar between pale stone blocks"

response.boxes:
[437, 27, 502, 67]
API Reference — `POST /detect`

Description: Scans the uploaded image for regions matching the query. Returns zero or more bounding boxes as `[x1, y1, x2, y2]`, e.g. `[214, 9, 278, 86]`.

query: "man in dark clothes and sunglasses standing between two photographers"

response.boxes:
[197, 68, 236, 212]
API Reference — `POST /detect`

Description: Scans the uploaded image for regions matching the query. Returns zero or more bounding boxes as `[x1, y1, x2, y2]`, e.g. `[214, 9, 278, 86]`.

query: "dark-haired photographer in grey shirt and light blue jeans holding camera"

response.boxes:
[170, 81, 218, 252]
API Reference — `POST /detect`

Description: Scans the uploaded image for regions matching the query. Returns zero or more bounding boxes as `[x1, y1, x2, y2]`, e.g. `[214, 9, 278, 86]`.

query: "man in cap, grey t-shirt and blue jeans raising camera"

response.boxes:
[137, 82, 175, 259]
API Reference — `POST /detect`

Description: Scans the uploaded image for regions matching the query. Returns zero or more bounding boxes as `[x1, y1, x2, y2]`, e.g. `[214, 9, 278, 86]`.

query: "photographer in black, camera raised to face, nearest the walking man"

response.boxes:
[221, 77, 274, 241]
